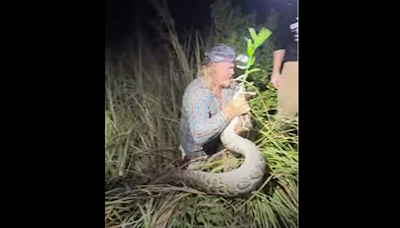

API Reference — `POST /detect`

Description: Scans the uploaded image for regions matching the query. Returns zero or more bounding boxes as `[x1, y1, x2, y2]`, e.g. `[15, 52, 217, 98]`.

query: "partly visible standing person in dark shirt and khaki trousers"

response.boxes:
[271, 0, 298, 119]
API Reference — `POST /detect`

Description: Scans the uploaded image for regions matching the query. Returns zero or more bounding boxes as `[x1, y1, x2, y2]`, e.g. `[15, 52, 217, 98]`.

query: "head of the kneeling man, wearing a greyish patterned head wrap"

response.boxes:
[202, 44, 236, 87]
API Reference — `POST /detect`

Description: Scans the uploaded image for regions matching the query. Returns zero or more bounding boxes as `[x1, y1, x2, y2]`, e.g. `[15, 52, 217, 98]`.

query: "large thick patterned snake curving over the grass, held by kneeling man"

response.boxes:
[105, 86, 267, 197]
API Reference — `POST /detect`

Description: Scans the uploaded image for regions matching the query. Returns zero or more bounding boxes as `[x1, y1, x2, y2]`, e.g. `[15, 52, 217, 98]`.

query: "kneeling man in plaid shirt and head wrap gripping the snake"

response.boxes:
[181, 44, 250, 160]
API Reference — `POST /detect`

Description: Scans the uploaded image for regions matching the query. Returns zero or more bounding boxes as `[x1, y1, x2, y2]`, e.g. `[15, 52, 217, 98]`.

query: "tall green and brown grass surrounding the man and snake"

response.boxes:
[105, 0, 298, 228]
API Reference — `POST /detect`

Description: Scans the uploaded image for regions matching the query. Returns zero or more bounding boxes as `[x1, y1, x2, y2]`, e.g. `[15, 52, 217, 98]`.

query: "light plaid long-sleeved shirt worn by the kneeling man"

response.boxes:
[181, 78, 235, 158]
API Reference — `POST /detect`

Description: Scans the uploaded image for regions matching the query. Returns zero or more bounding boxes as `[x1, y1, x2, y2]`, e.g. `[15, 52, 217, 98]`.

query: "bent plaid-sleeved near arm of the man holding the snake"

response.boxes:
[184, 89, 230, 145]
